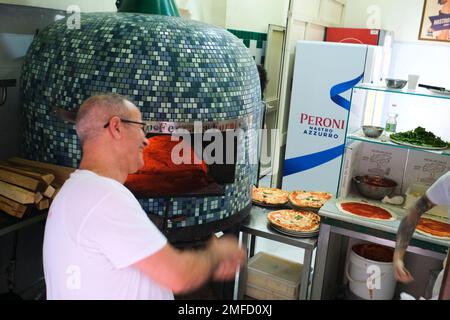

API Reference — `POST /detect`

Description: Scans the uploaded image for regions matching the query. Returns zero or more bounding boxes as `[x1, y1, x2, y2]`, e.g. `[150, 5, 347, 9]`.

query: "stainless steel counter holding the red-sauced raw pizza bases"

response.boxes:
[311, 198, 450, 300]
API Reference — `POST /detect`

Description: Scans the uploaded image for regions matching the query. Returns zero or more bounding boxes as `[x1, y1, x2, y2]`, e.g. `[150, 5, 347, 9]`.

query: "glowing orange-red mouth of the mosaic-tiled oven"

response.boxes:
[125, 123, 240, 198]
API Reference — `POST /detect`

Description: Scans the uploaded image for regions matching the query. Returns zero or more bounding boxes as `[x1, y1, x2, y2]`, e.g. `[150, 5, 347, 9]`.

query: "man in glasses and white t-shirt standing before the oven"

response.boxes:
[43, 94, 245, 299]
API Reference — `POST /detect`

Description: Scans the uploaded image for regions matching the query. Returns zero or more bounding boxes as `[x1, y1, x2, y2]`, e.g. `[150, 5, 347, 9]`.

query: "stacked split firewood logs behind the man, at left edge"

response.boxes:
[0, 157, 75, 218]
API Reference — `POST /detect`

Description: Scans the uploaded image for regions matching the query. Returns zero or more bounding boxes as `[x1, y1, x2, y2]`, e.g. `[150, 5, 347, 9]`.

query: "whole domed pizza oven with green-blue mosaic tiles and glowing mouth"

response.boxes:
[21, 13, 261, 241]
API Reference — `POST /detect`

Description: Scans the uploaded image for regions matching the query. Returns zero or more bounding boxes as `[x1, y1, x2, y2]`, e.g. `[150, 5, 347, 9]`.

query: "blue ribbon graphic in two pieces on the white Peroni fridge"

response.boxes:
[283, 73, 364, 177]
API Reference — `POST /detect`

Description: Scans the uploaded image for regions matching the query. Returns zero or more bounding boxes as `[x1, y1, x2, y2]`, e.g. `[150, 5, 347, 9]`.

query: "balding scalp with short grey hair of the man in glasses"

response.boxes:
[76, 93, 136, 145]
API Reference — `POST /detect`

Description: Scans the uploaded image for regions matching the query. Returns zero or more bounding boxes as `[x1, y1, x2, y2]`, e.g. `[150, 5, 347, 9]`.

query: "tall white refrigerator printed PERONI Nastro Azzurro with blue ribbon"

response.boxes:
[282, 41, 390, 195]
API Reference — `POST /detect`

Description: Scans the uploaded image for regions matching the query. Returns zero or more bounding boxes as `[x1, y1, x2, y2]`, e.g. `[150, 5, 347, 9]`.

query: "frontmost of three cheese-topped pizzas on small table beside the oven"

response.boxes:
[267, 210, 320, 232]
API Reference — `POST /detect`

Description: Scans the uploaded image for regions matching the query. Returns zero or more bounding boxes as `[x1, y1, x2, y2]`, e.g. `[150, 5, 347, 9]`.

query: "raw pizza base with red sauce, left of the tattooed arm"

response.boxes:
[336, 201, 395, 221]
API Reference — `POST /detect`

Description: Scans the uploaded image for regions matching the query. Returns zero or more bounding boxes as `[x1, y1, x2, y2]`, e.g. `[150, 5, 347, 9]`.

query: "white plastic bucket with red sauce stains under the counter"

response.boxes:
[345, 243, 396, 300]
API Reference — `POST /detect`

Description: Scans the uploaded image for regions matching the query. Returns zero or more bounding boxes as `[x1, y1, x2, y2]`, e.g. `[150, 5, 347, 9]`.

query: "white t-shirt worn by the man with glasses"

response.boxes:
[43, 170, 173, 299]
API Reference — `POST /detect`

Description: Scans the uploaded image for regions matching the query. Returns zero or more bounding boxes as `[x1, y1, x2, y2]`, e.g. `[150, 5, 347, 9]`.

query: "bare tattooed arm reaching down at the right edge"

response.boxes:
[394, 195, 434, 282]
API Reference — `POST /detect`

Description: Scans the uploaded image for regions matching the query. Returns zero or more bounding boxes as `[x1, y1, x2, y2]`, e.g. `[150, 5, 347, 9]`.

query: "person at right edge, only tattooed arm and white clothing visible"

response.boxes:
[394, 171, 450, 297]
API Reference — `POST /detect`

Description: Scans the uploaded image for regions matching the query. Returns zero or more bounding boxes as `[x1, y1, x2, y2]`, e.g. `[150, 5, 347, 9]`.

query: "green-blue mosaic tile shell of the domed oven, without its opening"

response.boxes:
[21, 13, 261, 242]
